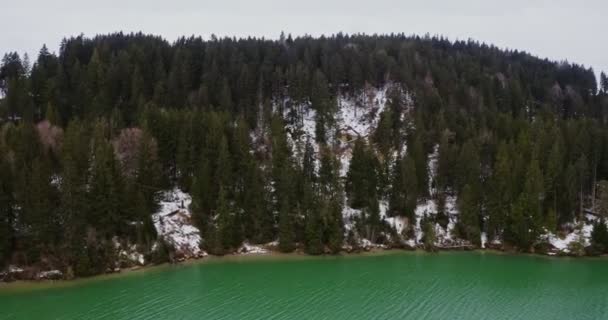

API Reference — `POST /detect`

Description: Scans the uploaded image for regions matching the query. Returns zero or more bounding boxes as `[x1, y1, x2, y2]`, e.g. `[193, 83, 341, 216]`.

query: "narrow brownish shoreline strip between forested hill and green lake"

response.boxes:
[0, 248, 608, 294]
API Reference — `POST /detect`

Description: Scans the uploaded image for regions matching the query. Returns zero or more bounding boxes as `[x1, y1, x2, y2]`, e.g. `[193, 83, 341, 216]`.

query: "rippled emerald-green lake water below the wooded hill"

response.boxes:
[0, 252, 608, 320]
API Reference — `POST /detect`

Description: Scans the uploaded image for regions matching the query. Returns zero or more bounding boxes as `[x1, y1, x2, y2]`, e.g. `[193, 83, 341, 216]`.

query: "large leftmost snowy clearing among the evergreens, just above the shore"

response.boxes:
[152, 188, 206, 257]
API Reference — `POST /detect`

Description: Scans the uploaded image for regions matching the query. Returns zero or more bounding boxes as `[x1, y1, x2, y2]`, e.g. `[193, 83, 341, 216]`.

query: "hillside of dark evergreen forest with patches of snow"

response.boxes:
[0, 33, 608, 276]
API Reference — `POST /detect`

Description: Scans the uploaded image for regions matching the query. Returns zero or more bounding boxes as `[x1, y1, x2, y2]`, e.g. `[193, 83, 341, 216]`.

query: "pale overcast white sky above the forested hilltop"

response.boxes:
[0, 0, 608, 76]
